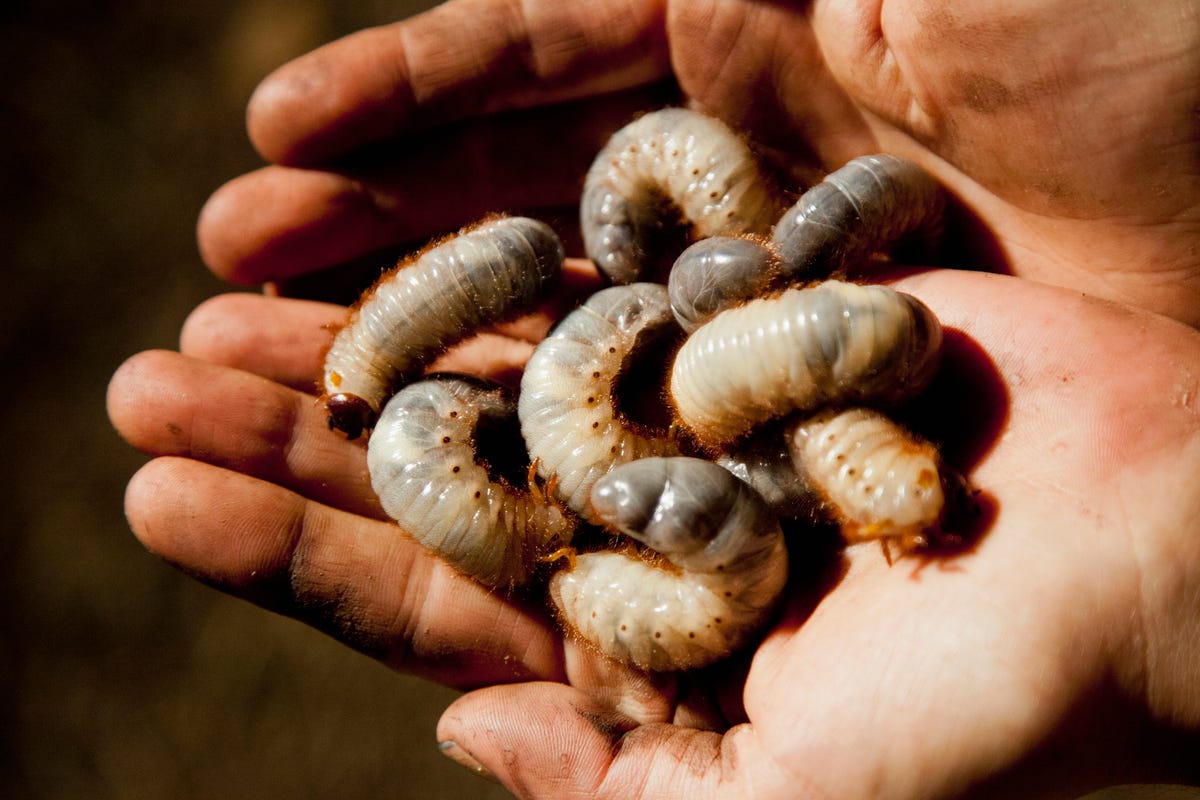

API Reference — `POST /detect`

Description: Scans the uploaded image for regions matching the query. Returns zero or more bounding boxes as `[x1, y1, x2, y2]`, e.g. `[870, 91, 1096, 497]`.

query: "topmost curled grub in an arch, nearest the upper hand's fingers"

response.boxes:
[580, 108, 779, 283]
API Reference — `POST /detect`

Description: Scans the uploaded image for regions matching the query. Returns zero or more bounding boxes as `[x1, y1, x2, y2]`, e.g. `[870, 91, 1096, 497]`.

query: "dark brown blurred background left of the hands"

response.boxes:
[0, 0, 509, 800]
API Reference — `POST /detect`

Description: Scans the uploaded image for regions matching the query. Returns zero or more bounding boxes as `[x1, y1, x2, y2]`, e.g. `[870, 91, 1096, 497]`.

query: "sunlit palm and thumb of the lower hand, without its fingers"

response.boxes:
[438, 271, 1200, 799]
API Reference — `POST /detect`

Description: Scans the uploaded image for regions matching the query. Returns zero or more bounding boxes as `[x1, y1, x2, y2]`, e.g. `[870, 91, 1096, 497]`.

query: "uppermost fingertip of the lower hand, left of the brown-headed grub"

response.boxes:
[180, 293, 346, 392]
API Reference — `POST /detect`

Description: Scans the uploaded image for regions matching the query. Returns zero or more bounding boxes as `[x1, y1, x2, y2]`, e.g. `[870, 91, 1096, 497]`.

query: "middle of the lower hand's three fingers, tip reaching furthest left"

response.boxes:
[108, 350, 385, 518]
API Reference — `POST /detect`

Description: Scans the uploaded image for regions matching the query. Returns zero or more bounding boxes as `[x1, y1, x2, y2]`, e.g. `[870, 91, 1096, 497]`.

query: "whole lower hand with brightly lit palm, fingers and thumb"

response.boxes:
[109, 271, 1200, 798]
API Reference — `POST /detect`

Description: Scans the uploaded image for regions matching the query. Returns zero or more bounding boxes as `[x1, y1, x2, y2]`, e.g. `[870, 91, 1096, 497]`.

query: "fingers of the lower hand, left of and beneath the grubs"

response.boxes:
[108, 259, 596, 687]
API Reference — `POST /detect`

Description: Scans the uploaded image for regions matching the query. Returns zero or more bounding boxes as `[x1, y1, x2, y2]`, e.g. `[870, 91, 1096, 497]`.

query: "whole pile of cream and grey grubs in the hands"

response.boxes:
[323, 108, 966, 672]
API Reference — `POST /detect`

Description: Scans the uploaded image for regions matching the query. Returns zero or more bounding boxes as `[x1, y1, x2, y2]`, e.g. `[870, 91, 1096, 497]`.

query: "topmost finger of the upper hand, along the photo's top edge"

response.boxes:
[247, 0, 670, 164]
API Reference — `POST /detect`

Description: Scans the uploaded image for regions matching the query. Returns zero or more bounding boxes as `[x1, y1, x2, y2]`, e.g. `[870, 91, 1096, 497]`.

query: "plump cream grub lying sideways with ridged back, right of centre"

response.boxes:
[670, 281, 942, 446]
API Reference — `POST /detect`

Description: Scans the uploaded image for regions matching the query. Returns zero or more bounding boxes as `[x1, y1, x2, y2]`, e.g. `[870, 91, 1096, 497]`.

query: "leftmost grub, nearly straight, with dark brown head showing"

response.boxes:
[324, 217, 563, 439]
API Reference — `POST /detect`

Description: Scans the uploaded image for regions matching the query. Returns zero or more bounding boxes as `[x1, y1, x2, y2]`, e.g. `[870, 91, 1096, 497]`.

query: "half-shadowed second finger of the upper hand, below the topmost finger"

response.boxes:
[197, 90, 664, 283]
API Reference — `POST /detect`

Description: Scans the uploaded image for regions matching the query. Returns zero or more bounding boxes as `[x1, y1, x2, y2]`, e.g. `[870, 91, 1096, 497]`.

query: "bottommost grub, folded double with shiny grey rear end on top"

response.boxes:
[550, 457, 787, 672]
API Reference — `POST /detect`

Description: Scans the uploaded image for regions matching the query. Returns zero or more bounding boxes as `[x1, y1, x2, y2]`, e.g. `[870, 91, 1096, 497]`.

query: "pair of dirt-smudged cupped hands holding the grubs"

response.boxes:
[131, 0, 1200, 796]
